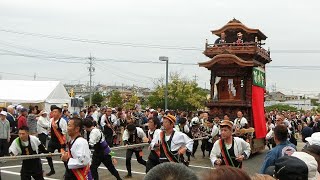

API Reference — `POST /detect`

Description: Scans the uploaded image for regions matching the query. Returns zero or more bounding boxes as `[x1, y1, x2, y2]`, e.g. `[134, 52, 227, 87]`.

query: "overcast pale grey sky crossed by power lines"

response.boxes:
[0, 0, 320, 94]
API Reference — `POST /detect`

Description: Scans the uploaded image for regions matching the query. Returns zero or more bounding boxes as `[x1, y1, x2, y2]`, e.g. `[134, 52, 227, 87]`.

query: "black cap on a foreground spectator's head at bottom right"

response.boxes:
[274, 156, 308, 180]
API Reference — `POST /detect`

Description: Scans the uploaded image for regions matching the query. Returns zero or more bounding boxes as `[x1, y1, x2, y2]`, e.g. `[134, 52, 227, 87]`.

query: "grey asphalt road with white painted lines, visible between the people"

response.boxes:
[0, 142, 303, 180]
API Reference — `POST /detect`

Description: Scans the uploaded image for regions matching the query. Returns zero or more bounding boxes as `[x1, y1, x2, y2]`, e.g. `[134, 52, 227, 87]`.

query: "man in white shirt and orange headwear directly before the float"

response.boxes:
[210, 120, 251, 168]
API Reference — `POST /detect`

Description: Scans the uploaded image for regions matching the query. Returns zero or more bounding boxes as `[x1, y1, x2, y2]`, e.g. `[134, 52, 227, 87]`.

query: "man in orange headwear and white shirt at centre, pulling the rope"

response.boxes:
[150, 114, 193, 165]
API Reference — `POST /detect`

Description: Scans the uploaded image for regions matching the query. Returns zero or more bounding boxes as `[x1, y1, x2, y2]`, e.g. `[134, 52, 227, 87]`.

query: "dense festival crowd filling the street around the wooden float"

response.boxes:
[0, 104, 320, 180]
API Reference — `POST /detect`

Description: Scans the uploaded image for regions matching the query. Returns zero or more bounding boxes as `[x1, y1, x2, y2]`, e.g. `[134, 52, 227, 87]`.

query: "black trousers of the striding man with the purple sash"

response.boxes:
[90, 155, 121, 180]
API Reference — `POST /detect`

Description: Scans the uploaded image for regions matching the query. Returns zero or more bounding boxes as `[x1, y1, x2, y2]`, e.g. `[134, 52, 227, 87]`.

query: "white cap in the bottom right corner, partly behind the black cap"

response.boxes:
[291, 152, 319, 180]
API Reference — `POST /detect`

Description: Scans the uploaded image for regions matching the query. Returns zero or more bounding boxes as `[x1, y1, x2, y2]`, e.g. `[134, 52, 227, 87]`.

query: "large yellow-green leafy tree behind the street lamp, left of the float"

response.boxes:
[148, 74, 207, 110]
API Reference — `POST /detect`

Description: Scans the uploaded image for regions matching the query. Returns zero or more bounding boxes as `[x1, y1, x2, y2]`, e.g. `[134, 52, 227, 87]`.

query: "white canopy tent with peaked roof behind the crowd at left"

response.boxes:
[0, 80, 71, 111]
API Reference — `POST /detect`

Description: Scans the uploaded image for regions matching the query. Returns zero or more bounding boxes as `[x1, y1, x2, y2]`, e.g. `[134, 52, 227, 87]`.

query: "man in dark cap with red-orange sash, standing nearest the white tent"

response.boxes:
[46, 106, 67, 176]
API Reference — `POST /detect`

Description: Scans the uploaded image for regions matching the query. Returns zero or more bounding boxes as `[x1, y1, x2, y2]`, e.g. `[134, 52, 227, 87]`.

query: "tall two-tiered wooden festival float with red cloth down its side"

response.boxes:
[199, 19, 271, 153]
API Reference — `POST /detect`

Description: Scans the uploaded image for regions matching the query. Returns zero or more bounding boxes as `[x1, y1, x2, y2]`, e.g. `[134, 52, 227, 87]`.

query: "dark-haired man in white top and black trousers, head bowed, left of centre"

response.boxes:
[122, 124, 148, 179]
